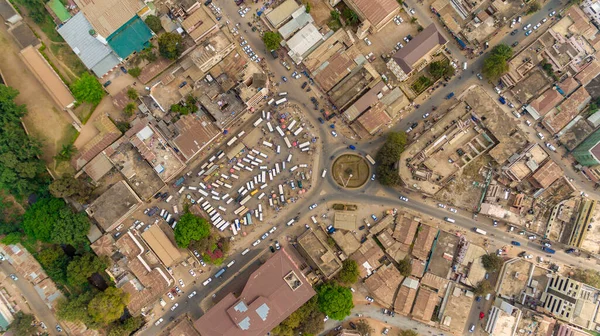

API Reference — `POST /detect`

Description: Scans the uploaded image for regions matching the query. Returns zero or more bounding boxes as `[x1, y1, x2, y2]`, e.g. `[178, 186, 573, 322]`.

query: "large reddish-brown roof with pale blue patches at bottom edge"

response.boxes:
[194, 249, 315, 336]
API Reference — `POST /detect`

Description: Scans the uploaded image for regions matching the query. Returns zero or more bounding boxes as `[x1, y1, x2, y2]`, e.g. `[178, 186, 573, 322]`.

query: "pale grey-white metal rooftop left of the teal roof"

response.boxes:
[57, 12, 120, 77]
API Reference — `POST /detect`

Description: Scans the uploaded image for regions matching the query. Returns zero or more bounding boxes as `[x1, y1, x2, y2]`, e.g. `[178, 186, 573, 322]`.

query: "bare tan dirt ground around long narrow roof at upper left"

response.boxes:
[0, 21, 73, 166]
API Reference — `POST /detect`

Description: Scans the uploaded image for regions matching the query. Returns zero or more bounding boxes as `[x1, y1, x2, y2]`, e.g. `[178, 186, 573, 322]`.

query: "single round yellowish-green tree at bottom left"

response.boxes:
[88, 287, 129, 324]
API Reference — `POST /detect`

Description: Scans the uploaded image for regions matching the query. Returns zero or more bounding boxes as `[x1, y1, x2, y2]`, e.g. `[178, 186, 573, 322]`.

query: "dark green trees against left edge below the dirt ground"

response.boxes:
[0, 85, 49, 199]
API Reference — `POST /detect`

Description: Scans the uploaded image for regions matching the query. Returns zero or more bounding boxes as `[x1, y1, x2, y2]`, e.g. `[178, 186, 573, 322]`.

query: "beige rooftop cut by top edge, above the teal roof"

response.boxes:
[74, 0, 144, 38]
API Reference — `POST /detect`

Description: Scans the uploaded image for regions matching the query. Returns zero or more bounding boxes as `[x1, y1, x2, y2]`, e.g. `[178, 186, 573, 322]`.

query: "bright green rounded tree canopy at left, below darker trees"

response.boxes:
[22, 197, 90, 247]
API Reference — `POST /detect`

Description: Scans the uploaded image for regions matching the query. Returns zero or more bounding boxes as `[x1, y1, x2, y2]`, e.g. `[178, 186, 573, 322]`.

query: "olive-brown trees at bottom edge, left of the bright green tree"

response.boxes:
[271, 296, 325, 336]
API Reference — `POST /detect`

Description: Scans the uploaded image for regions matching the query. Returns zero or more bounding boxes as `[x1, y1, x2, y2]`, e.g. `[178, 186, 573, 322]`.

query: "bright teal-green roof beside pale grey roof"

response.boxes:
[106, 15, 152, 58]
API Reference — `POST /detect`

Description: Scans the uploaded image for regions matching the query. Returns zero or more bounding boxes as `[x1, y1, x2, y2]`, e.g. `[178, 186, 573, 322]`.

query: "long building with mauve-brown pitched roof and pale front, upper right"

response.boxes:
[387, 23, 448, 81]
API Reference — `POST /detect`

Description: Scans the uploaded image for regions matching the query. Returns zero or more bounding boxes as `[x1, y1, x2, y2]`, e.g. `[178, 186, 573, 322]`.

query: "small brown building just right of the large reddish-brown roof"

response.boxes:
[297, 230, 342, 279]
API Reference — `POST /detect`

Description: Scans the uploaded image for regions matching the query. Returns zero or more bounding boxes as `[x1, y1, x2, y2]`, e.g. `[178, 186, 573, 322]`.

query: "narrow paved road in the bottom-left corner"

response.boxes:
[0, 261, 59, 335]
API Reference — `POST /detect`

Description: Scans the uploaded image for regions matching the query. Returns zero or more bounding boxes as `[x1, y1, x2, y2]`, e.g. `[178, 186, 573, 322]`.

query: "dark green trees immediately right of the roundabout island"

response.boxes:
[375, 132, 406, 186]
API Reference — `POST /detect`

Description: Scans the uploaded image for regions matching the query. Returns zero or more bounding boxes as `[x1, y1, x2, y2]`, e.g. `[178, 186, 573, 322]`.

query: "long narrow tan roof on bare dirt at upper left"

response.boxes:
[20, 46, 75, 109]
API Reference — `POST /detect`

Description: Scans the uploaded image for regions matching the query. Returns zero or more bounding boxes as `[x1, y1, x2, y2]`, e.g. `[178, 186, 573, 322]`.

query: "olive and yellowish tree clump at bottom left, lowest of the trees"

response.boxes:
[57, 286, 130, 329]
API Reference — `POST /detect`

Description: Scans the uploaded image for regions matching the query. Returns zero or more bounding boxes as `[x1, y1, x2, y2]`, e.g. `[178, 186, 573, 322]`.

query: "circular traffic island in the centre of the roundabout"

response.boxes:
[331, 153, 371, 189]
